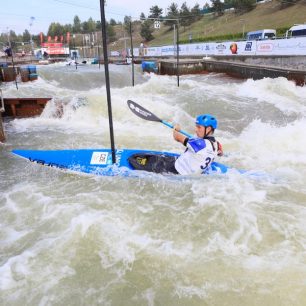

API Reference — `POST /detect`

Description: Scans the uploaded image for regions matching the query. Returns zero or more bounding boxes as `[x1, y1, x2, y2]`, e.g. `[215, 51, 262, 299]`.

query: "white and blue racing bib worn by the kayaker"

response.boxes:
[175, 137, 217, 175]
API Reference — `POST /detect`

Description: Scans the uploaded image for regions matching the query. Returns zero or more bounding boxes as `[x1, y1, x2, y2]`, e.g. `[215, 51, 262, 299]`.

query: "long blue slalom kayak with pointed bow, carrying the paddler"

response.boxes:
[12, 149, 229, 176]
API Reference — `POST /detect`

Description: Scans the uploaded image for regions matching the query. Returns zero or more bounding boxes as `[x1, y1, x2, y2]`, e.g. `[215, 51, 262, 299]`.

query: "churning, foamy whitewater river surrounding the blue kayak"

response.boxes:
[0, 64, 306, 306]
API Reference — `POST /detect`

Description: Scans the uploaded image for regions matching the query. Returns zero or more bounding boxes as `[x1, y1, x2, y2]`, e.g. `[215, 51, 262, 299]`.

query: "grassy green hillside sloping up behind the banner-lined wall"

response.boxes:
[112, 0, 306, 49]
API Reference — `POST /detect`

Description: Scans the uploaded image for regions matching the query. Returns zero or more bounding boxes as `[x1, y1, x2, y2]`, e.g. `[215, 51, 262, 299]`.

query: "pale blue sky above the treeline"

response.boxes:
[0, 0, 209, 34]
